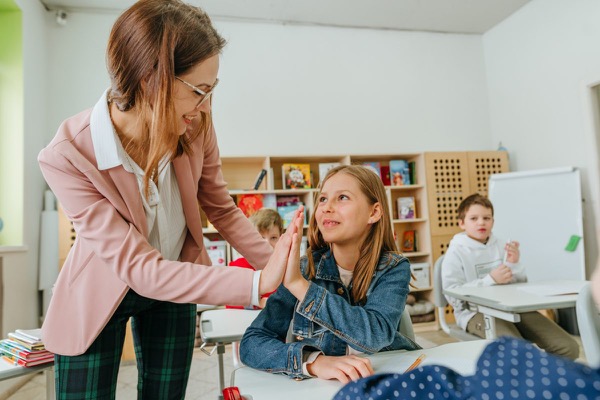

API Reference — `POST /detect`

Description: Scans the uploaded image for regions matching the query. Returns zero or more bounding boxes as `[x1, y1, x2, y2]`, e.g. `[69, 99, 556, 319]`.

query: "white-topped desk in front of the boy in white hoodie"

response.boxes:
[444, 280, 588, 339]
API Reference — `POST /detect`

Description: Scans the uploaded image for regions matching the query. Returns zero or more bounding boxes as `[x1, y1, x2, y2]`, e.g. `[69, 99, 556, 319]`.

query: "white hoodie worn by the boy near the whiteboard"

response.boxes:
[442, 232, 527, 330]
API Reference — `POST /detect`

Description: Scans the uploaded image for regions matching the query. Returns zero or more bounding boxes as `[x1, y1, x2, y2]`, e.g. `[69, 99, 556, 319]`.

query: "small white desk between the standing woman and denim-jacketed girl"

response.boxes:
[200, 309, 260, 398]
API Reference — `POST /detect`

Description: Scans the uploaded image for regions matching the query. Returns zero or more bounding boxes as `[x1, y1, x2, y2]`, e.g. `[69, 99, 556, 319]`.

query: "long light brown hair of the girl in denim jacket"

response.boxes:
[306, 165, 398, 302]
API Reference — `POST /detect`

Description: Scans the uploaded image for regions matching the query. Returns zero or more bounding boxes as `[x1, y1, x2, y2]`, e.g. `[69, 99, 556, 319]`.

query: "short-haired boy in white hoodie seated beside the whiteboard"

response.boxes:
[442, 194, 579, 360]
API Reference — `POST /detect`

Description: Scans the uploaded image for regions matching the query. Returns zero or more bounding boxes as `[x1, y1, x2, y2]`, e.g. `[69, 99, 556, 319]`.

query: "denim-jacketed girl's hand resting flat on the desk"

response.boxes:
[306, 354, 374, 383]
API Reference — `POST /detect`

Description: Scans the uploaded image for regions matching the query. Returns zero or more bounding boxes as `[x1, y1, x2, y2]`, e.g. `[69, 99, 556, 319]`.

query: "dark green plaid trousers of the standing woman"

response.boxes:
[54, 289, 196, 400]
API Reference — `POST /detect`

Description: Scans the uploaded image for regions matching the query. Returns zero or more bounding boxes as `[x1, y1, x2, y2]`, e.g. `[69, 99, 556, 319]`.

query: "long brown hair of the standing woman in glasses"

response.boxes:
[106, 0, 225, 196]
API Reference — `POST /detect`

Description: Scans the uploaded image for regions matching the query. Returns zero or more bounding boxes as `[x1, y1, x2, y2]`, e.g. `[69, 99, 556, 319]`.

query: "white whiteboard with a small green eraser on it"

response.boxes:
[489, 167, 585, 282]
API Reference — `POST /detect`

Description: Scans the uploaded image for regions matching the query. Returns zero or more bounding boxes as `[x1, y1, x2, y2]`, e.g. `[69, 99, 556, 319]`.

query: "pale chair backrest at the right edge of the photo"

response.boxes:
[576, 283, 600, 368]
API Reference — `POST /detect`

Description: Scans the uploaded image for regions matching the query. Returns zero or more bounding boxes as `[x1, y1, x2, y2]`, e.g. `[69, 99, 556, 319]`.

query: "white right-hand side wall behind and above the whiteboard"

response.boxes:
[483, 0, 600, 276]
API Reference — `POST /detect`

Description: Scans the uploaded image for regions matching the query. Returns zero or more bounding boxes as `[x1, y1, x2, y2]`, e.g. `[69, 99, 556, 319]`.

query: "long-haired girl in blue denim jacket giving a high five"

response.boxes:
[240, 165, 420, 382]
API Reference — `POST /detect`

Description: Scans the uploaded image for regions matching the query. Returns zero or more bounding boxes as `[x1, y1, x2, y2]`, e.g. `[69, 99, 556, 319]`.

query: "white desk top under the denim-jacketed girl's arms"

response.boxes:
[232, 340, 490, 400]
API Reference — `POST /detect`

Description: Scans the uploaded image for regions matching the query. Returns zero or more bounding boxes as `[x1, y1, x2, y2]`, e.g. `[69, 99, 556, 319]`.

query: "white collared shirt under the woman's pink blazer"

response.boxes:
[90, 90, 187, 261]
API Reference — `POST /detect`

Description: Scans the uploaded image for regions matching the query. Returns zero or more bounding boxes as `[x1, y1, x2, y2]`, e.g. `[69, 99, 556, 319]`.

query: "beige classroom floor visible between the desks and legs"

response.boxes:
[8, 331, 583, 400]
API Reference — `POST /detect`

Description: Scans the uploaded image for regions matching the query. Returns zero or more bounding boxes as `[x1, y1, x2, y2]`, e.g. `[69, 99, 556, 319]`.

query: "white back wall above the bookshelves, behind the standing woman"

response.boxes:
[46, 13, 496, 155]
